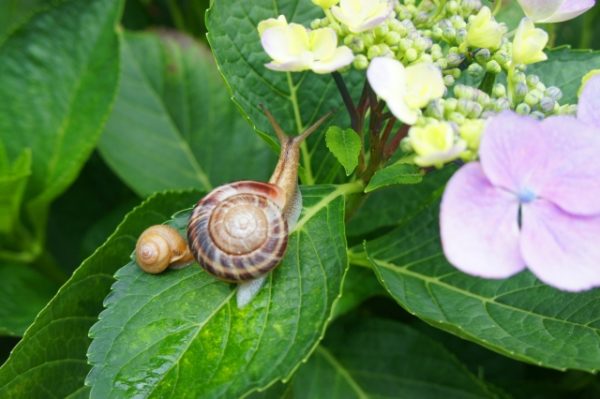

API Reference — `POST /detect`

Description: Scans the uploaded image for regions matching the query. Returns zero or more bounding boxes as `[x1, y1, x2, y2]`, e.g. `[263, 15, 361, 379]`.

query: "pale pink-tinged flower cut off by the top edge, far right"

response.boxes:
[518, 0, 595, 23]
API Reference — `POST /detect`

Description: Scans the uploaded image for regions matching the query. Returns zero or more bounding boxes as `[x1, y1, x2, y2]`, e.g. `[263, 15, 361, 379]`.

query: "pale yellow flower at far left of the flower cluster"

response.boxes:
[258, 16, 354, 74]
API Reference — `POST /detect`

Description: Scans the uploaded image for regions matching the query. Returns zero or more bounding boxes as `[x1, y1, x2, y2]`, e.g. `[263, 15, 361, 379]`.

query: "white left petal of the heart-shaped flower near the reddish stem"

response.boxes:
[367, 57, 419, 125]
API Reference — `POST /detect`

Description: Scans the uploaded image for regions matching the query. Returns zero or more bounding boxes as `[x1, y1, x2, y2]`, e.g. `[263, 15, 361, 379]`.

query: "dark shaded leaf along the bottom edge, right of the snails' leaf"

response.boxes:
[291, 318, 497, 399]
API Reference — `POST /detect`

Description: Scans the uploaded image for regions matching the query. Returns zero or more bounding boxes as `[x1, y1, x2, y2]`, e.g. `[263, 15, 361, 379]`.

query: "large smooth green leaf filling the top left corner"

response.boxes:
[0, 0, 122, 235]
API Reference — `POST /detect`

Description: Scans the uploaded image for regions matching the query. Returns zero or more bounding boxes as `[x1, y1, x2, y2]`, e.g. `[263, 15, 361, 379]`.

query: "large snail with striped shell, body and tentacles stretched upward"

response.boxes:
[187, 109, 330, 288]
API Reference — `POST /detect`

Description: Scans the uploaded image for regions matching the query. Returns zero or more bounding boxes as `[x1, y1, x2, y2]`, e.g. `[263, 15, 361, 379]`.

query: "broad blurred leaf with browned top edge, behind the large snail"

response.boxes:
[99, 31, 275, 196]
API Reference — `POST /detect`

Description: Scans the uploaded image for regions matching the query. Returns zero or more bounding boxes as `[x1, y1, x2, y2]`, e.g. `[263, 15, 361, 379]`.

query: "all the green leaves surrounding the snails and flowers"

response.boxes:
[0, 0, 600, 398]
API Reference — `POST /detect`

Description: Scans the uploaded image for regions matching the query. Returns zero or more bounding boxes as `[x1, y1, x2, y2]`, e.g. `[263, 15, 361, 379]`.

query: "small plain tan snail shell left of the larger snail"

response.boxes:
[135, 225, 193, 274]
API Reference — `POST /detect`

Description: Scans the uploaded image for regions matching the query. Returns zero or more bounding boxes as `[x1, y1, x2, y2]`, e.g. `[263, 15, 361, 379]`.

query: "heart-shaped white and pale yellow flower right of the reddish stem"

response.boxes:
[367, 57, 446, 125]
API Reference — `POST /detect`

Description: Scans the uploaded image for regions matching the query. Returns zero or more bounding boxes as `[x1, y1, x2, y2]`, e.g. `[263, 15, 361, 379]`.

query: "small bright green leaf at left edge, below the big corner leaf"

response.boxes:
[0, 147, 31, 234]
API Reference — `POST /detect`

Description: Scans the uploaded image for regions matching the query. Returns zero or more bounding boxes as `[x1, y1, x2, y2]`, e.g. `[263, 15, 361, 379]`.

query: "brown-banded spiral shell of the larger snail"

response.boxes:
[188, 181, 288, 282]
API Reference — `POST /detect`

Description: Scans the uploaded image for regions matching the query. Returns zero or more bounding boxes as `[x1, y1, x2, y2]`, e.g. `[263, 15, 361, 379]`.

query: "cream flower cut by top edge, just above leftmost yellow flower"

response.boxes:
[331, 0, 394, 33]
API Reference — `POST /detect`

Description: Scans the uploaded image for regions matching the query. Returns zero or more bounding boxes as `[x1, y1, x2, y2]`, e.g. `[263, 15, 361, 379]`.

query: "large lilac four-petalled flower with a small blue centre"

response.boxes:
[440, 77, 600, 291]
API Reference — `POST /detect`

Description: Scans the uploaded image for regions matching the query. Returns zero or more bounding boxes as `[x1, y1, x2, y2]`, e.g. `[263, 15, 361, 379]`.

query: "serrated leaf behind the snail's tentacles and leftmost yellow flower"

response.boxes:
[207, 0, 363, 183]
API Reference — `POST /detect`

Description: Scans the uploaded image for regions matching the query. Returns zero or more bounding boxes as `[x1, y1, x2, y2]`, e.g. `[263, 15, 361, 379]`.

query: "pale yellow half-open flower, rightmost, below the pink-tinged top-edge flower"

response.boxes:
[512, 18, 548, 65]
